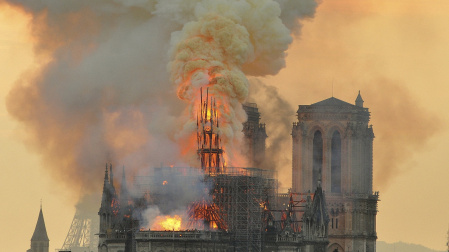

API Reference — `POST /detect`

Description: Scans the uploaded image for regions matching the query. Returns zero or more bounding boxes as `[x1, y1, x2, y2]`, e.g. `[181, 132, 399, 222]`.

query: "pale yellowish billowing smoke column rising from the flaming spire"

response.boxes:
[170, 0, 318, 166]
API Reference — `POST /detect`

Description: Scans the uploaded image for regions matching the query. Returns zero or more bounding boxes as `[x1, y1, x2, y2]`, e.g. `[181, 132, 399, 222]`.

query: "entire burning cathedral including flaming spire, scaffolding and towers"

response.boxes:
[94, 90, 378, 252]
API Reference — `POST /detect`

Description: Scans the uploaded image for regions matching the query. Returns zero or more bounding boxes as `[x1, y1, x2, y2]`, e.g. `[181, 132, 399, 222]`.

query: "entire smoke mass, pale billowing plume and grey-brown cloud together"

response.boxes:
[3, 0, 317, 202]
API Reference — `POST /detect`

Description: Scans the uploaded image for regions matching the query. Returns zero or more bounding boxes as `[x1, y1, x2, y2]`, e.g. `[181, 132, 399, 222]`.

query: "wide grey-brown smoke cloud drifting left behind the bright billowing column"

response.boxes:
[2, 0, 317, 202]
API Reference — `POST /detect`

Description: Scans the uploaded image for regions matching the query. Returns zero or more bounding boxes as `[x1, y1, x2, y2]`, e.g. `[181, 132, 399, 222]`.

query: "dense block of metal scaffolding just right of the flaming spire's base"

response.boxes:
[206, 167, 277, 251]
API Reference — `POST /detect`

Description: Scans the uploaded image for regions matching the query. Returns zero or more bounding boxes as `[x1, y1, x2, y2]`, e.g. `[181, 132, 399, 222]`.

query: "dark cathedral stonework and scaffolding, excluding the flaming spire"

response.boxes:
[50, 92, 379, 252]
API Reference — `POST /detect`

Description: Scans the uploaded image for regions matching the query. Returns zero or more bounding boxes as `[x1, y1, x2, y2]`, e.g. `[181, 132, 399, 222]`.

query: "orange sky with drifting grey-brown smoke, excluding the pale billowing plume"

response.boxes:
[0, 0, 449, 251]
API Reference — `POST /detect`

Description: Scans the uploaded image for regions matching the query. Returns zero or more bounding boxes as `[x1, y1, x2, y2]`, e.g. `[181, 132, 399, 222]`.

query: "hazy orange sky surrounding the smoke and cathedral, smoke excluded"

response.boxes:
[0, 0, 449, 251]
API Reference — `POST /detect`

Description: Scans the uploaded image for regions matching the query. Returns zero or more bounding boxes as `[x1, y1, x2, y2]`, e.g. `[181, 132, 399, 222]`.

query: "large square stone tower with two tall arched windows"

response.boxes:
[292, 92, 378, 252]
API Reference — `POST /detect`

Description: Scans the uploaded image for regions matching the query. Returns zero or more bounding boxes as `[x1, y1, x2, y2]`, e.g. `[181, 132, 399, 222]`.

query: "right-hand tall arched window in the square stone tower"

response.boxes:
[331, 131, 341, 193]
